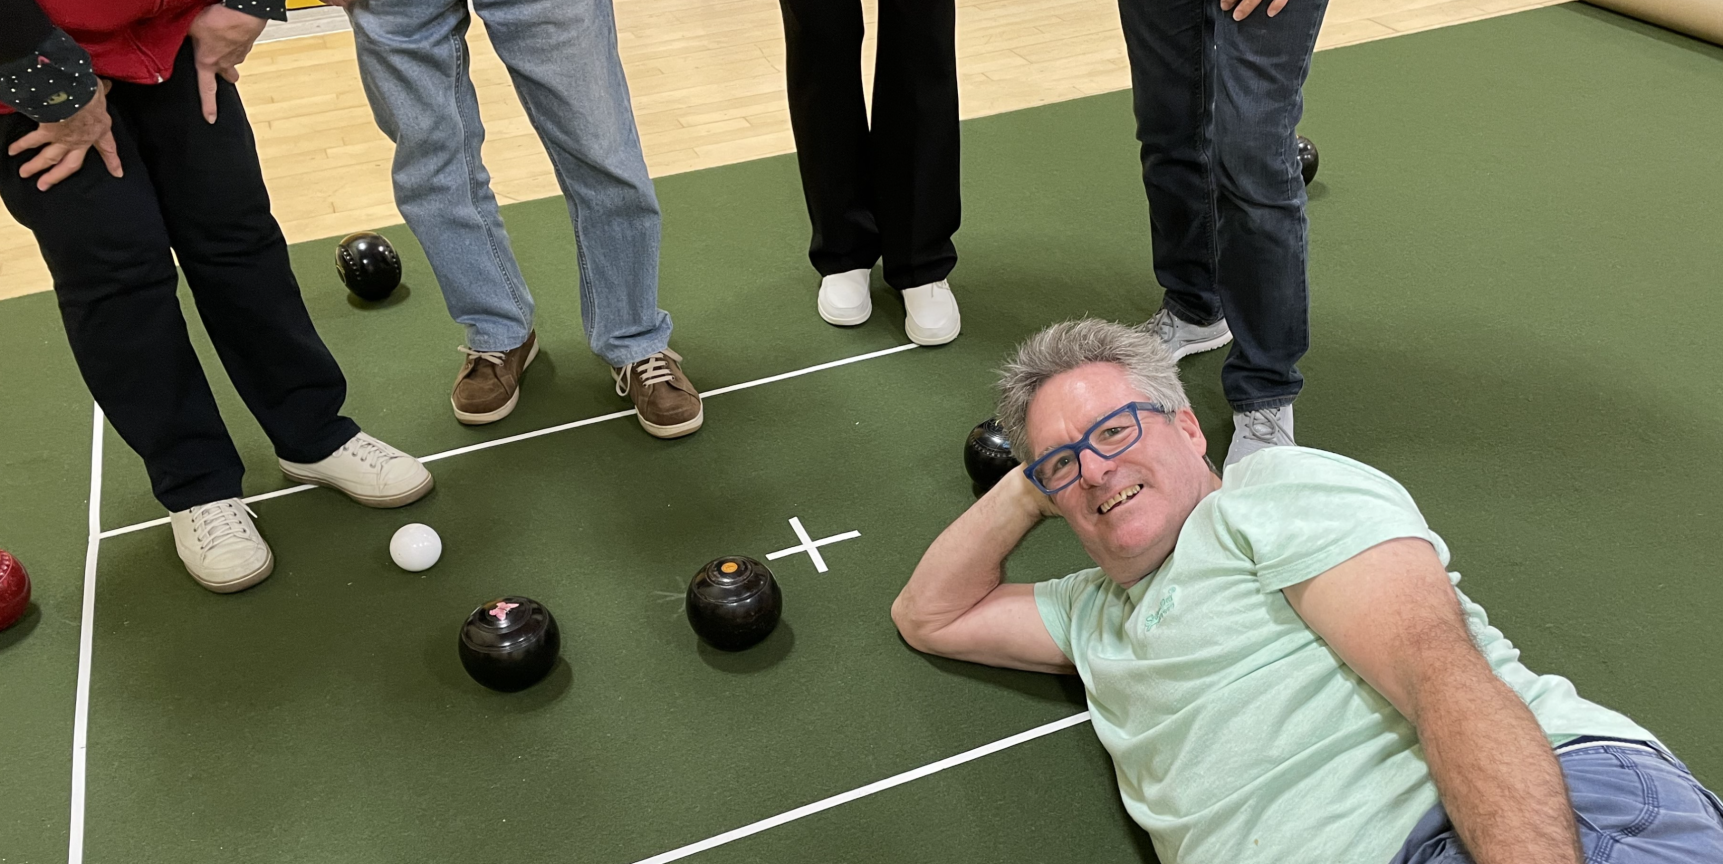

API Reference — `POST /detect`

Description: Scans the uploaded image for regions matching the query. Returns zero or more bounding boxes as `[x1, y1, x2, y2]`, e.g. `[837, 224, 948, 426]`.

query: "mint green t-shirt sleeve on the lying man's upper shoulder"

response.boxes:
[1216, 447, 1447, 593]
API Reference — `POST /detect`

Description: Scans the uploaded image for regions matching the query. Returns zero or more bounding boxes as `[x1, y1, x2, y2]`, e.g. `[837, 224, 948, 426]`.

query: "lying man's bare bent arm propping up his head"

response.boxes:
[891, 471, 1073, 673]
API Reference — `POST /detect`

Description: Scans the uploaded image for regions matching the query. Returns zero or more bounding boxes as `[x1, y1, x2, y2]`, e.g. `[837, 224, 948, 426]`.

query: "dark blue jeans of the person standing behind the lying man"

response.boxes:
[1118, 0, 1328, 410]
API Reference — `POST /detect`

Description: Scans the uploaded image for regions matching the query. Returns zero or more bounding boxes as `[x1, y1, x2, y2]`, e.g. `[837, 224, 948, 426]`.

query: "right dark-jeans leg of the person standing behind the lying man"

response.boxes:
[1211, 0, 1328, 412]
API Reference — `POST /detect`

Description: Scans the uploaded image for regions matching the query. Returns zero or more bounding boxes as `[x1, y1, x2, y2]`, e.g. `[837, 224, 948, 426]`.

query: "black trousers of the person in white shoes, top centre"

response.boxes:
[779, 0, 961, 290]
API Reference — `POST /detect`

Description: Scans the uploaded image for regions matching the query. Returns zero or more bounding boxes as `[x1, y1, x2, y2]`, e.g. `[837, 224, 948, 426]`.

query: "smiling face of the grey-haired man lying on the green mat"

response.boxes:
[1027, 362, 1220, 585]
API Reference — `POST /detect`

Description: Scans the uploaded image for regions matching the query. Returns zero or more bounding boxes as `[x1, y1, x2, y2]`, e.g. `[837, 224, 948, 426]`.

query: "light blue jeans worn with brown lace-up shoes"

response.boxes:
[348, 0, 670, 366]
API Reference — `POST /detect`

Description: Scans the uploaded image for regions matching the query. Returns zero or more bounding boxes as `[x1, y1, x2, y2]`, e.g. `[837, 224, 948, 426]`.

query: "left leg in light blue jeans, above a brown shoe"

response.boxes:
[348, 0, 532, 352]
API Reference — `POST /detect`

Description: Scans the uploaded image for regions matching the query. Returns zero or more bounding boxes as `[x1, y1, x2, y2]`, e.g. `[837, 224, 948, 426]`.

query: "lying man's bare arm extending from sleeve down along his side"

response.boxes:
[1285, 538, 1583, 864]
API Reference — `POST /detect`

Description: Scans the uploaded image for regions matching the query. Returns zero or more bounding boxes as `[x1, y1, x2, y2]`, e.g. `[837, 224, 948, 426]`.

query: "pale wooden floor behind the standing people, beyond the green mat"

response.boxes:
[0, 0, 1561, 298]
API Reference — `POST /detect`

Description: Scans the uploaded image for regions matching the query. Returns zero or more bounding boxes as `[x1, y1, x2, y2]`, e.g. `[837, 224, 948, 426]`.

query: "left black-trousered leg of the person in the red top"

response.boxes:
[0, 106, 245, 510]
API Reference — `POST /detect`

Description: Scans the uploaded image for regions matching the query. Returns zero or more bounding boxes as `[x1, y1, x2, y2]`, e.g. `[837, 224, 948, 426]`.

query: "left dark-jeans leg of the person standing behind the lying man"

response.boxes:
[1118, 0, 1225, 327]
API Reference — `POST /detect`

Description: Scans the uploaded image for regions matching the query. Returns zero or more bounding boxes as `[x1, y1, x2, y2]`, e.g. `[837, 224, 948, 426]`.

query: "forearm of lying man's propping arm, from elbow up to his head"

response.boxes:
[893, 471, 1042, 635]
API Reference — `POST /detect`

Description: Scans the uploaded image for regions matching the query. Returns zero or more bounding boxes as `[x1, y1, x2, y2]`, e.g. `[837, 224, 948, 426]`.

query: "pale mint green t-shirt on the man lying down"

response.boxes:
[1036, 447, 1651, 864]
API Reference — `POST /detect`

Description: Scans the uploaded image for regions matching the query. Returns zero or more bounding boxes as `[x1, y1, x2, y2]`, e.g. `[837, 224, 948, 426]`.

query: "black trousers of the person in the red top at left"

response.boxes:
[0, 41, 358, 510]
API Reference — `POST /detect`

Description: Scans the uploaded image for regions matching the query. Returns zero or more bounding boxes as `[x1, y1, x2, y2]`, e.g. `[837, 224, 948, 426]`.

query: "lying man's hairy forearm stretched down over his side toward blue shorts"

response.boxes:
[1416, 659, 1583, 864]
